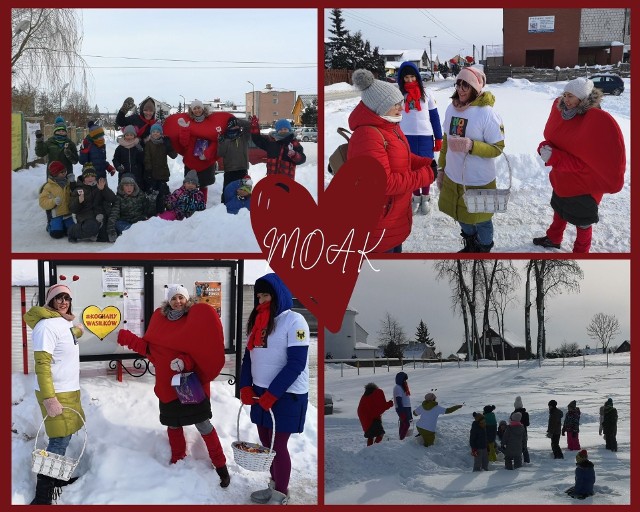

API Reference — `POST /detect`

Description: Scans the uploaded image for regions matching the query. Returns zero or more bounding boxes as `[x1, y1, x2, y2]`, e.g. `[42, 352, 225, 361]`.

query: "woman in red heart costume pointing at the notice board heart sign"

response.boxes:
[118, 285, 231, 487]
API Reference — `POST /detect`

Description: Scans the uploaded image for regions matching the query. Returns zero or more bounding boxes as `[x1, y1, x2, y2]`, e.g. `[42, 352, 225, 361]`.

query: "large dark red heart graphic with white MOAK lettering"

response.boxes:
[251, 156, 386, 332]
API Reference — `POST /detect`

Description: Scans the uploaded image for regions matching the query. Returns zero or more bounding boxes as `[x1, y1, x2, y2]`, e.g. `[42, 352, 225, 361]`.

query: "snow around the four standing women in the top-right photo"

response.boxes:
[324, 73, 631, 253]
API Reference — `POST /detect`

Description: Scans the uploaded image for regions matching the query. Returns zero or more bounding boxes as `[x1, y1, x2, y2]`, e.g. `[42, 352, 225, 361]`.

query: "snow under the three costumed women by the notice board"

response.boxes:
[11, 338, 318, 505]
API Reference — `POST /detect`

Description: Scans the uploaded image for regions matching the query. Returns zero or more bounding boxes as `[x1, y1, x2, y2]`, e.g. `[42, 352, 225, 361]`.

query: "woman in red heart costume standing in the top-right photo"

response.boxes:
[533, 78, 626, 253]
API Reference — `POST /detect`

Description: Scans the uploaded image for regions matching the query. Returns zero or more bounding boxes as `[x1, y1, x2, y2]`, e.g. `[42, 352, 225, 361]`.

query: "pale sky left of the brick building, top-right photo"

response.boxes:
[324, 8, 502, 60]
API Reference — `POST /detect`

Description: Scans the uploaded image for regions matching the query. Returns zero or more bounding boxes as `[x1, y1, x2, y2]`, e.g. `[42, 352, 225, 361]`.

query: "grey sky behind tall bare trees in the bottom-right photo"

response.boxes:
[350, 260, 630, 356]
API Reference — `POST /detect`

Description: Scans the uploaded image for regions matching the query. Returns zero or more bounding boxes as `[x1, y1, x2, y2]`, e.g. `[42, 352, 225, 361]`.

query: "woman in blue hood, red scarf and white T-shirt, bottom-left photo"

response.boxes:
[240, 274, 309, 505]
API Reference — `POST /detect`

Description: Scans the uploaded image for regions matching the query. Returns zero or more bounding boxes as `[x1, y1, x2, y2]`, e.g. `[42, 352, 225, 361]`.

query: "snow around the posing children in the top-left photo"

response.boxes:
[11, 131, 318, 255]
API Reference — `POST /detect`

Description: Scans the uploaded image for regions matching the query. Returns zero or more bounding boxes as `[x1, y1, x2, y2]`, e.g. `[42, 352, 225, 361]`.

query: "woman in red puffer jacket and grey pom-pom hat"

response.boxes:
[347, 69, 433, 253]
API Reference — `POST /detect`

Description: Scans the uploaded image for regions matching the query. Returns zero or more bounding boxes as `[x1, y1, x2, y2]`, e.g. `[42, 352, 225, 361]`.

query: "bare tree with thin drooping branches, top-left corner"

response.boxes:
[11, 9, 89, 114]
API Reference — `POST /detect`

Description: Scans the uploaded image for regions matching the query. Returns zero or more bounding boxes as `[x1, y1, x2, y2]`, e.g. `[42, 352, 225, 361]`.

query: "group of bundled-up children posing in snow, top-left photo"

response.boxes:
[36, 105, 306, 242]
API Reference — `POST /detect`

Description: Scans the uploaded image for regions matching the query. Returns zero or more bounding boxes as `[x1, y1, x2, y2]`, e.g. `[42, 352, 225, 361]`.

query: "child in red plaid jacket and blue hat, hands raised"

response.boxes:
[251, 116, 307, 180]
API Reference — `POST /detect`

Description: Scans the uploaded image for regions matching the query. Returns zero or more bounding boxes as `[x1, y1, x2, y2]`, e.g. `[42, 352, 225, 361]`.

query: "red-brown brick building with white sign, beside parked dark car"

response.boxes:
[502, 8, 631, 68]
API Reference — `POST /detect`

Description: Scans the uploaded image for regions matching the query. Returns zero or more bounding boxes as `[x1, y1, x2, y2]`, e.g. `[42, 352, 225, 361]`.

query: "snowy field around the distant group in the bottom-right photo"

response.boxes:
[324, 353, 631, 505]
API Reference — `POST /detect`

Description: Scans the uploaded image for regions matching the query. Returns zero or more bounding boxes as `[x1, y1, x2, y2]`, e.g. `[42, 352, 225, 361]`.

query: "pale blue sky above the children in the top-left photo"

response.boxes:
[76, 8, 318, 112]
